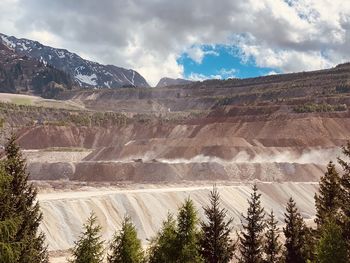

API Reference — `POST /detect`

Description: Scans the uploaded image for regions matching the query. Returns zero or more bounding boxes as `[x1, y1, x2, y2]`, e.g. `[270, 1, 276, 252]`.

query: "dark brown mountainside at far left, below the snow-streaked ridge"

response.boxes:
[0, 43, 74, 98]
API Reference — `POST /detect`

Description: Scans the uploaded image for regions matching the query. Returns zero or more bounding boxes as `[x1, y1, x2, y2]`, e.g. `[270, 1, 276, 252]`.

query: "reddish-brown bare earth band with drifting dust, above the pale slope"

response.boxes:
[19, 112, 350, 182]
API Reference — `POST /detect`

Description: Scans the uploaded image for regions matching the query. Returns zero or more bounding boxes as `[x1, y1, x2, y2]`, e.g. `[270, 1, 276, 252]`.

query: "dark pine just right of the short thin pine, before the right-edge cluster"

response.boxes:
[283, 198, 307, 263]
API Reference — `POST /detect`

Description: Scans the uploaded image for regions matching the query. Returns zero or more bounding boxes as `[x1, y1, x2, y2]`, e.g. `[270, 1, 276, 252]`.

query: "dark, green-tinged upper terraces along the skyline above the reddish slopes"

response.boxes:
[58, 63, 350, 115]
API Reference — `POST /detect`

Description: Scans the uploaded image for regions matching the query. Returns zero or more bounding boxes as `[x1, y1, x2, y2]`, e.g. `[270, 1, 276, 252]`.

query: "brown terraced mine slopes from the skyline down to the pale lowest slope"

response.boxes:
[0, 64, 350, 182]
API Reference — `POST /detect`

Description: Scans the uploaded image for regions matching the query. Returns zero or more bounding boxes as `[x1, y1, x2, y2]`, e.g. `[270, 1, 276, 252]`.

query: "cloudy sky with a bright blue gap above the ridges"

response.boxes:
[0, 0, 350, 85]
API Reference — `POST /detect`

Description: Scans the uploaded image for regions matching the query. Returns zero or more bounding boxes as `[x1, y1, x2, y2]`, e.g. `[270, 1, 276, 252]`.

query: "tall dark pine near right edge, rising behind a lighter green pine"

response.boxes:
[315, 162, 341, 229]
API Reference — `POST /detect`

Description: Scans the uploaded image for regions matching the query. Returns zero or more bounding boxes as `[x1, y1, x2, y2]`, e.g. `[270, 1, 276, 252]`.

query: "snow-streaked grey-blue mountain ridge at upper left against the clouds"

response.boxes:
[0, 33, 149, 88]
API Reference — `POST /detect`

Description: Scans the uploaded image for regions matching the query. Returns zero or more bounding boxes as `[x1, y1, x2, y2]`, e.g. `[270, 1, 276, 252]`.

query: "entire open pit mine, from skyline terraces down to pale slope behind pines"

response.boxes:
[0, 64, 350, 262]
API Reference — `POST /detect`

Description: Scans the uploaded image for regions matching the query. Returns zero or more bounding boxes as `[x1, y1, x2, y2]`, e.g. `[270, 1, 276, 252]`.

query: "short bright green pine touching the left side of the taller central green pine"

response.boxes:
[149, 214, 177, 263]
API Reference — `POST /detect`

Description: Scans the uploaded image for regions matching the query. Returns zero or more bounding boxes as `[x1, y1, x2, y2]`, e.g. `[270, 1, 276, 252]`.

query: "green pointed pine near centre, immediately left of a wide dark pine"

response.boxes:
[176, 198, 203, 263]
